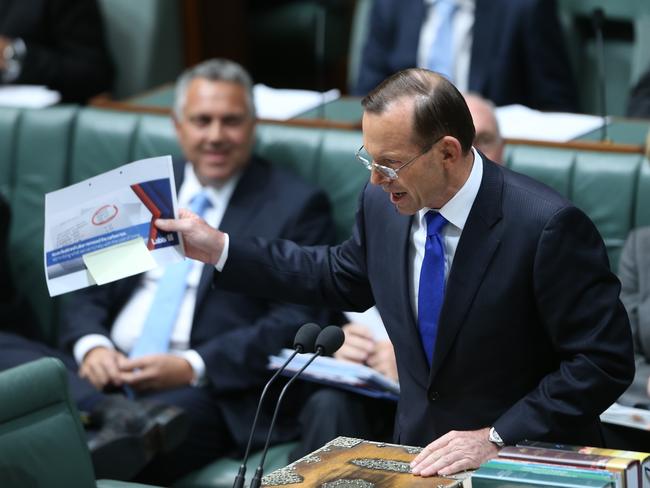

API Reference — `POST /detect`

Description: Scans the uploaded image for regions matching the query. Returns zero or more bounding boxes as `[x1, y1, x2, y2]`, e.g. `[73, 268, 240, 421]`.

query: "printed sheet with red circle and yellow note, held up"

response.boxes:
[43, 156, 185, 296]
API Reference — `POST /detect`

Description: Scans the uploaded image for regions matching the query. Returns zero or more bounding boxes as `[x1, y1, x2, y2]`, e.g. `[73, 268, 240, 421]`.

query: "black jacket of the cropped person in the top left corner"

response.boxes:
[13, 0, 113, 103]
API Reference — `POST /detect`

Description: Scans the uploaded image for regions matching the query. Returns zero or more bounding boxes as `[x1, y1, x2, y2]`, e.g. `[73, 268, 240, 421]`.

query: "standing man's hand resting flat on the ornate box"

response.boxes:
[411, 427, 499, 476]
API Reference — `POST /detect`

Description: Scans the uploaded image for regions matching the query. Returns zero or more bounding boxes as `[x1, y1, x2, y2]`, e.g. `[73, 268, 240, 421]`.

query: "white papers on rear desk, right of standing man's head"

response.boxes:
[496, 105, 603, 142]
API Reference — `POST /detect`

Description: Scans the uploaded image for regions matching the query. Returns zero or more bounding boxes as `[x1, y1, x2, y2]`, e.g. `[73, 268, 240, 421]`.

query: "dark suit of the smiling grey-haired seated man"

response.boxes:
[61, 157, 333, 480]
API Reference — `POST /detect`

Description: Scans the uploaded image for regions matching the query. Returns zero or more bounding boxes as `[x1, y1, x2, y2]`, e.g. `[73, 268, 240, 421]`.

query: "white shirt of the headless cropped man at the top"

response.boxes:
[417, 0, 475, 92]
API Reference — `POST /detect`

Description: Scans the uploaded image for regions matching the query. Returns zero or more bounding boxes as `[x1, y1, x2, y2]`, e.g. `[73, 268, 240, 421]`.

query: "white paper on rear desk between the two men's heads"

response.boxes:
[253, 84, 341, 120]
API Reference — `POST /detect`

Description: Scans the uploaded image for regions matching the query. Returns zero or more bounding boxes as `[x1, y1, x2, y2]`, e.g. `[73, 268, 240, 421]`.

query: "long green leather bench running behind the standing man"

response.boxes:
[0, 106, 650, 487]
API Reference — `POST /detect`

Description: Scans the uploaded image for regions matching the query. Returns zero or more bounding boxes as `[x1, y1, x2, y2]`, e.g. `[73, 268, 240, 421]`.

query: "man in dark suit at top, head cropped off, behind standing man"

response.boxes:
[354, 0, 578, 112]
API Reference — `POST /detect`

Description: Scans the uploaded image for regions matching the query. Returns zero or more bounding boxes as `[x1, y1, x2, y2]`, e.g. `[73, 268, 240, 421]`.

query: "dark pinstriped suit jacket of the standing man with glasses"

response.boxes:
[215, 156, 634, 445]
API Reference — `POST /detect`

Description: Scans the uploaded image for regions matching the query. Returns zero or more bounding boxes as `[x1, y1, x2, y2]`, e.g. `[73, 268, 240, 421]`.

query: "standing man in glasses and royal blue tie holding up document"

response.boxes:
[157, 69, 634, 476]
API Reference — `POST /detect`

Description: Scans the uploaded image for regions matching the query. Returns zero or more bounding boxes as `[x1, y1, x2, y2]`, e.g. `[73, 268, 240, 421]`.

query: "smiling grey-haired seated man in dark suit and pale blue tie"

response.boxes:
[55, 60, 333, 484]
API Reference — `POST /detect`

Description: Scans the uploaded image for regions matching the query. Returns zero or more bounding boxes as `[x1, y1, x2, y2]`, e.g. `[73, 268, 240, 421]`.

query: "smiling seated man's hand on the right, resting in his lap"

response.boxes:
[119, 354, 194, 390]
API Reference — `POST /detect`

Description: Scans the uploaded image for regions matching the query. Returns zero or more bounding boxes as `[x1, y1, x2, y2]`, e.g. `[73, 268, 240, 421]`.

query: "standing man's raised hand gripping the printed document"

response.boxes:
[155, 208, 226, 265]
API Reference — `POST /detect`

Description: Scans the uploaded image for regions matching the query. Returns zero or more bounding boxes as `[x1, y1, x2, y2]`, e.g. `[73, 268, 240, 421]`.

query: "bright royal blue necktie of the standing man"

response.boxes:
[418, 212, 447, 366]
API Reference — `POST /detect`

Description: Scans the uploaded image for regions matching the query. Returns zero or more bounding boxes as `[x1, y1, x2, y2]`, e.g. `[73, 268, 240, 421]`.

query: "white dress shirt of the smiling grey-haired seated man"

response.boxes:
[73, 163, 240, 384]
